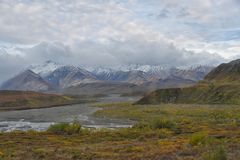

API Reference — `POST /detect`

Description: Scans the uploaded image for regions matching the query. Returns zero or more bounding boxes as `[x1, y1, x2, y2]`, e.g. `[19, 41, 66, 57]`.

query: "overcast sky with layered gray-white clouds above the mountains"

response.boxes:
[0, 0, 240, 82]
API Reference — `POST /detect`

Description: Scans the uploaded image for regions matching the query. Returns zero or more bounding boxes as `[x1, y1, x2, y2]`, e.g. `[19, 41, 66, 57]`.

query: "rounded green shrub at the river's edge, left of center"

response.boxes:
[48, 122, 82, 135]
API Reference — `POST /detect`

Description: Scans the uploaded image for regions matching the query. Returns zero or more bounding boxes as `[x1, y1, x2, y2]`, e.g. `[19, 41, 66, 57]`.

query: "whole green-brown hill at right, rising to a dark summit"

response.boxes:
[137, 60, 240, 104]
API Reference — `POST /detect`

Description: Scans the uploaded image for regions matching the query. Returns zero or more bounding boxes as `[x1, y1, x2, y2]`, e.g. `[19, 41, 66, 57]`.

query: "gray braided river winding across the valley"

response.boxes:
[0, 95, 138, 132]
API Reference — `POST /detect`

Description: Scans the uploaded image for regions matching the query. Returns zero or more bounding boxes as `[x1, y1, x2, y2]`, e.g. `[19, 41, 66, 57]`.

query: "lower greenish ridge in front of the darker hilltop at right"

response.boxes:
[137, 83, 240, 104]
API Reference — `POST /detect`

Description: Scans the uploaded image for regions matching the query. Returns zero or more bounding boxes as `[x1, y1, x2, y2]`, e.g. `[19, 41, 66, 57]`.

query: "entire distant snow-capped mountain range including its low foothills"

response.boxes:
[1, 61, 213, 94]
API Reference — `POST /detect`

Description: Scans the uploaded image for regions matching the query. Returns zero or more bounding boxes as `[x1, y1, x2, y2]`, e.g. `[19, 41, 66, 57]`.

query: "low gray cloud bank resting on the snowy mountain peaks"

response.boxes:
[1, 39, 224, 73]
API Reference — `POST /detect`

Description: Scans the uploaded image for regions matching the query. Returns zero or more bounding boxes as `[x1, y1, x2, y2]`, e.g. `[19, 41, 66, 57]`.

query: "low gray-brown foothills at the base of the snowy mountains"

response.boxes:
[62, 78, 195, 95]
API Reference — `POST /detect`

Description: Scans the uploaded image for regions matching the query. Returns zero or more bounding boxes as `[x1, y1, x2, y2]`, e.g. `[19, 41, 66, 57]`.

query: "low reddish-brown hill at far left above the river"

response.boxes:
[0, 91, 76, 111]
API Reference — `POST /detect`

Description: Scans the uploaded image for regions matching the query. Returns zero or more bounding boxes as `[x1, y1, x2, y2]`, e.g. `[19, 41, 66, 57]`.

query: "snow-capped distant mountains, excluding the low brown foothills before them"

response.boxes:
[0, 61, 213, 90]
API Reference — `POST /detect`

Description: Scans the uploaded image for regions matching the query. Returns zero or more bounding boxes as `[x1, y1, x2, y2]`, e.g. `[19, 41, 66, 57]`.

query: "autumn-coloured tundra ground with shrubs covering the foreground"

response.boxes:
[0, 103, 240, 160]
